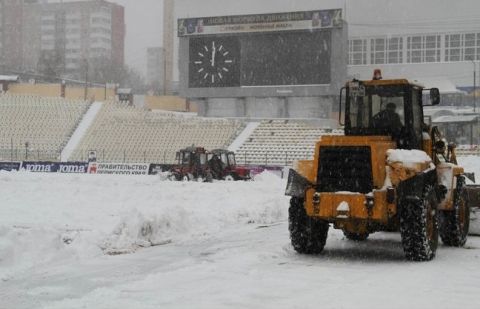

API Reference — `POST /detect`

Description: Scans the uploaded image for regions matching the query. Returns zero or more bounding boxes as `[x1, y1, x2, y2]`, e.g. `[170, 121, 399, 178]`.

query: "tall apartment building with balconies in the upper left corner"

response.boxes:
[0, 0, 125, 76]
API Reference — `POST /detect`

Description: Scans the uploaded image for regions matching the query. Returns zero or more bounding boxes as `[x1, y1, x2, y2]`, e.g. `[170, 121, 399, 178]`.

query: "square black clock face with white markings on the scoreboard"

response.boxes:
[189, 37, 240, 88]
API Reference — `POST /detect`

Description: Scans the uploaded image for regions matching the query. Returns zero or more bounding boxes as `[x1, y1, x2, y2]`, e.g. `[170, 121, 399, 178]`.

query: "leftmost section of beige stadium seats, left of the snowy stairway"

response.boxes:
[0, 94, 90, 161]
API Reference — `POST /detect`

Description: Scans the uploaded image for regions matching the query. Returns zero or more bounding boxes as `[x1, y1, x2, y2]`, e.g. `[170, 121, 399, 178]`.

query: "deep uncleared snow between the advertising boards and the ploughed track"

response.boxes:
[0, 172, 288, 279]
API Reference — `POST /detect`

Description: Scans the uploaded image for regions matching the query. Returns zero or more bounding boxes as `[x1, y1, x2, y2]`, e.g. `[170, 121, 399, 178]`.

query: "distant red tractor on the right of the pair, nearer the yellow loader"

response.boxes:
[208, 149, 251, 181]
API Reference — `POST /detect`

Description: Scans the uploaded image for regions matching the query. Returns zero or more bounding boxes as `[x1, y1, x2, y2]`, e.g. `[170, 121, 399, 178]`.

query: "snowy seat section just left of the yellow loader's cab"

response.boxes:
[236, 120, 343, 166]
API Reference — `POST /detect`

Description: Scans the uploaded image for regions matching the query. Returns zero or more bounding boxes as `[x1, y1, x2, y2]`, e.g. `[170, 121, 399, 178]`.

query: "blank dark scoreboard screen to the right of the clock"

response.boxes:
[241, 31, 331, 86]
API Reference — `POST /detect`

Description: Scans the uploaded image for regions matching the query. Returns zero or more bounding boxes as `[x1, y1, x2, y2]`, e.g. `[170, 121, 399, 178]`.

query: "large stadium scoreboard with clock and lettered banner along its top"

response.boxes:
[178, 9, 346, 97]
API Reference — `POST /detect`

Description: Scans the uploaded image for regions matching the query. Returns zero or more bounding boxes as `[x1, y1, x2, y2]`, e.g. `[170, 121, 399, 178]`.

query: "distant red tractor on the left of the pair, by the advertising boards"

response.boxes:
[168, 146, 212, 182]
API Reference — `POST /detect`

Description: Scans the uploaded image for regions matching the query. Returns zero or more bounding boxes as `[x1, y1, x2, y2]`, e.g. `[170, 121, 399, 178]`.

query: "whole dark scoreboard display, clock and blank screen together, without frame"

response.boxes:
[189, 29, 332, 88]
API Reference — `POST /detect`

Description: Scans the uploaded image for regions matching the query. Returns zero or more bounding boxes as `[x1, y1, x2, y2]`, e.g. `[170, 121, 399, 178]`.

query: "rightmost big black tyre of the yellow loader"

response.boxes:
[439, 176, 470, 247]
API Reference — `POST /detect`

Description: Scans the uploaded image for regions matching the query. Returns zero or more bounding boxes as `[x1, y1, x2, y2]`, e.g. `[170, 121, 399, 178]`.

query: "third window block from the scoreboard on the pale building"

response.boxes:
[407, 35, 441, 63]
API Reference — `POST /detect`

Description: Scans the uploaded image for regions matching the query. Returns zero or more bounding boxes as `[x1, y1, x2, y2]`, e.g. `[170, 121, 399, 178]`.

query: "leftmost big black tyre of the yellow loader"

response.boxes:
[288, 197, 329, 254]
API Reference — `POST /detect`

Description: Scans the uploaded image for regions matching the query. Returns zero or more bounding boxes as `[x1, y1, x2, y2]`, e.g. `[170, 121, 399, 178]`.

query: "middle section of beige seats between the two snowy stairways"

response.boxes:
[70, 102, 245, 164]
